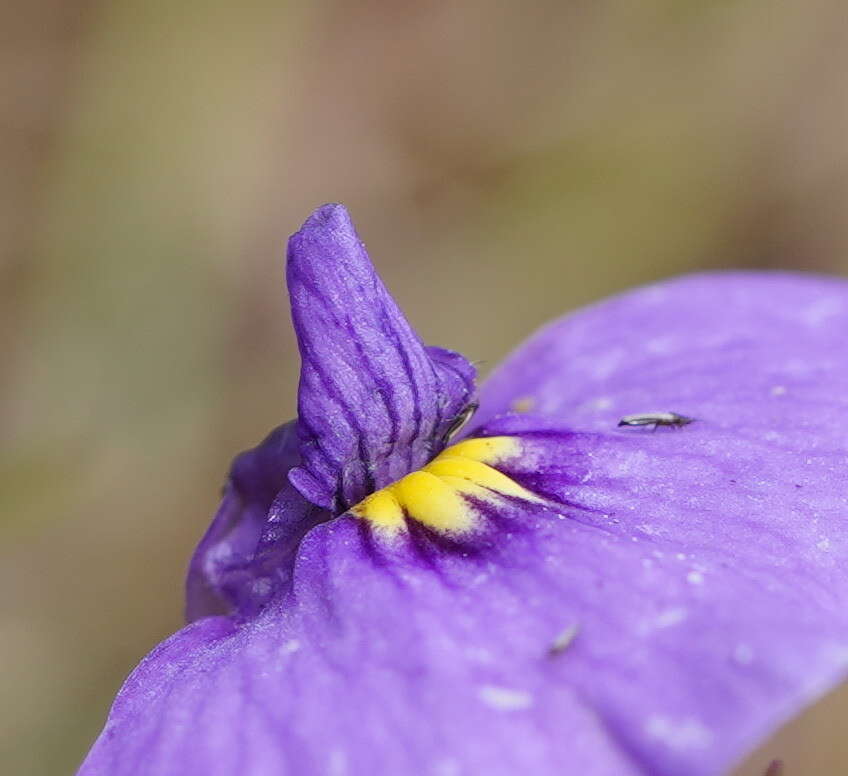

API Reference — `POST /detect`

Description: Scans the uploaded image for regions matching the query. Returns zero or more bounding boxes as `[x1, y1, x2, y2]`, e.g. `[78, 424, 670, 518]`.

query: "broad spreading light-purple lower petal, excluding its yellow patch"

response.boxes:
[82, 276, 848, 776]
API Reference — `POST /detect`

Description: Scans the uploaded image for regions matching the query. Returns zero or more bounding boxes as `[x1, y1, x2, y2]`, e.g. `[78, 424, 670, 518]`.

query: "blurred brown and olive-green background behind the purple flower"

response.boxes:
[0, 0, 848, 776]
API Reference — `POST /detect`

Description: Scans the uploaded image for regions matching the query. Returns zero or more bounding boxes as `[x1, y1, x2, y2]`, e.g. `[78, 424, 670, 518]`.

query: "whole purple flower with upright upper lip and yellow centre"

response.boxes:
[81, 205, 848, 776]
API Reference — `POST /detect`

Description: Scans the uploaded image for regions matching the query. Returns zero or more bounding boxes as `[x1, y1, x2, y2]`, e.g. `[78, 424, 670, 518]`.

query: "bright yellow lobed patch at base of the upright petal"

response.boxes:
[350, 437, 542, 534]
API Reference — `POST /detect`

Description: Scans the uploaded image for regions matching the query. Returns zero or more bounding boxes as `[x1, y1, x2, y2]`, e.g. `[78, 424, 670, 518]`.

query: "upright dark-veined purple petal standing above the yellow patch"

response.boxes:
[287, 205, 474, 511]
